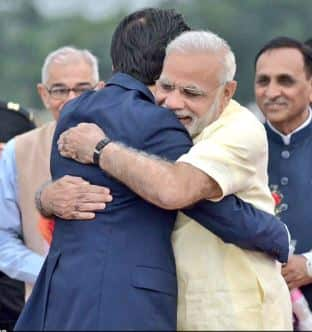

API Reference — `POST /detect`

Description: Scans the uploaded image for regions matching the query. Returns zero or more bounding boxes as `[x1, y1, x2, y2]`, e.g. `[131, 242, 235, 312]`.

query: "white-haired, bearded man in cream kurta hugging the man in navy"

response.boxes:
[55, 31, 292, 330]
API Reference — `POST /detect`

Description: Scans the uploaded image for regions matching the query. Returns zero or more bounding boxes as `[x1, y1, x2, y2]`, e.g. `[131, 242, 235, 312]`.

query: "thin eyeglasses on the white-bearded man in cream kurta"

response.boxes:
[156, 78, 226, 98]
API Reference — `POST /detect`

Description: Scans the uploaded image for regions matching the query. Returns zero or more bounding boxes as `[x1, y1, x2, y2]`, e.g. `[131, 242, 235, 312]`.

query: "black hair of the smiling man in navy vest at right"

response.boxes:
[255, 37, 312, 78]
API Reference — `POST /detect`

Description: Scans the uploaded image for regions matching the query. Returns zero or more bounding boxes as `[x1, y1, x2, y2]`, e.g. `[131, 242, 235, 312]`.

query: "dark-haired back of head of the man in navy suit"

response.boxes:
[111, 8, 190, 85]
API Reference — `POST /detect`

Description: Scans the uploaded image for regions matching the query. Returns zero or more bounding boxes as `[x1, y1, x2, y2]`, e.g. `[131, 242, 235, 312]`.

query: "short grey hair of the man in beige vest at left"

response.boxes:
[41, 46, 99, 84]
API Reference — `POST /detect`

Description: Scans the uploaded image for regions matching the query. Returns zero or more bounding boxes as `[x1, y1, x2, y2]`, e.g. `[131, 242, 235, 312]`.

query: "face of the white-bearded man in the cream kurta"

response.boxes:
[155, 53, 235, 136]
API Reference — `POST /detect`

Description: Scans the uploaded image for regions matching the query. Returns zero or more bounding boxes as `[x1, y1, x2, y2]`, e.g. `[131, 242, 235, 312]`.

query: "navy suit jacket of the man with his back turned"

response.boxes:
[16, 73, 288, 330]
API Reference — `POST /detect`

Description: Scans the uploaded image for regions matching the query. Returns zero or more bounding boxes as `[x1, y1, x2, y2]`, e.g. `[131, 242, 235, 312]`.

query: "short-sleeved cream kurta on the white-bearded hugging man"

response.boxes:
[172, 101, 292, 330]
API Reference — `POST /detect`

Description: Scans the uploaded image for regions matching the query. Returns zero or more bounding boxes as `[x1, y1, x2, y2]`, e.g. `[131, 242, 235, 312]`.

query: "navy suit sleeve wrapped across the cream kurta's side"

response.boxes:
[183, 195, 289, 263]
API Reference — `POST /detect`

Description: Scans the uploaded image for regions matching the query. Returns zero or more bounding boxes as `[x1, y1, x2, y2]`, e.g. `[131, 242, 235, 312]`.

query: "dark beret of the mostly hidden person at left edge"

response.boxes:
[0, 101, 36, 143]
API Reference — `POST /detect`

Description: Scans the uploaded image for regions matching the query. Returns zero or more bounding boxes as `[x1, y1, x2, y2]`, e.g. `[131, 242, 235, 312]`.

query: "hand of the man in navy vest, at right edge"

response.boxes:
[282, 255, 312, 289]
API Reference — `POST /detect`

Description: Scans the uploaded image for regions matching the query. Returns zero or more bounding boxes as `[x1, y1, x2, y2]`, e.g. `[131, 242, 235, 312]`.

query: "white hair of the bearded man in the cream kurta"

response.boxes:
[166, 31, 236, 84]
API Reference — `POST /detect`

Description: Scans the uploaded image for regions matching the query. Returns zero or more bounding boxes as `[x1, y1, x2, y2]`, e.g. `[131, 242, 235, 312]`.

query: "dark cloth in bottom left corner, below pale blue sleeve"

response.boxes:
[0, 272, 25, 331]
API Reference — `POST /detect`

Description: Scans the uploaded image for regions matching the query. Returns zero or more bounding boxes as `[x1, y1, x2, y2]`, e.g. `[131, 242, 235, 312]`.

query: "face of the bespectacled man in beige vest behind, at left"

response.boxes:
[37, 59, 103, 120]
